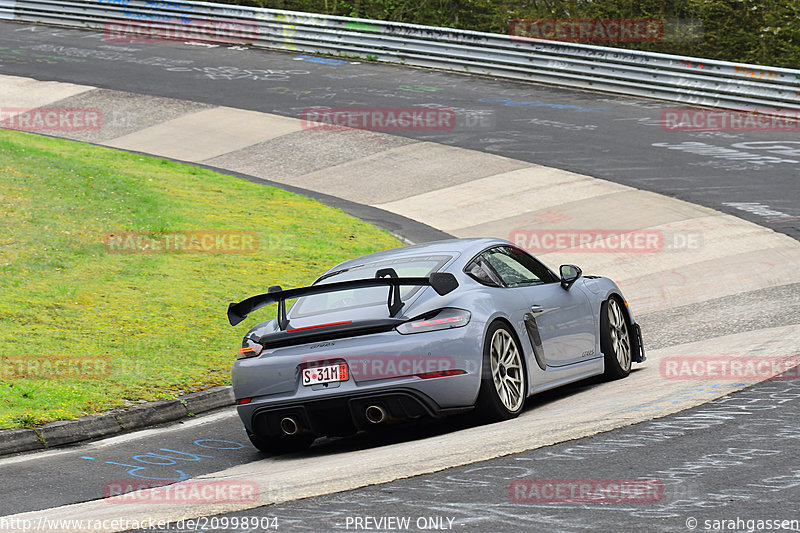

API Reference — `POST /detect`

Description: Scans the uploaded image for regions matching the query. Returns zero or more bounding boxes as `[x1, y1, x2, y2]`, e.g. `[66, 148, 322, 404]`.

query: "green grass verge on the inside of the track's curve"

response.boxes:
[0, 131, 400, 428]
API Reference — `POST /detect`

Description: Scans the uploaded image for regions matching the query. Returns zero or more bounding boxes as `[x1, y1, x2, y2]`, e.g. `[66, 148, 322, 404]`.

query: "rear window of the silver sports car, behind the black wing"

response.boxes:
[291, 255, 452, 318]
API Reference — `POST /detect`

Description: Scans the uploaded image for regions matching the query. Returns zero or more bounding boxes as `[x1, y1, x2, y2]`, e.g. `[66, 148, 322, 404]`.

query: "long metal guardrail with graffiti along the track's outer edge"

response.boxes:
[0, 0, 800, 117]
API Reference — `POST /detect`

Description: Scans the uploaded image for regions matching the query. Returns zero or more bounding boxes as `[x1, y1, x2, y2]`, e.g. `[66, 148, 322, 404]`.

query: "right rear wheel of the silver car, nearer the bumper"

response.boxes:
[475, 321, 528, 422]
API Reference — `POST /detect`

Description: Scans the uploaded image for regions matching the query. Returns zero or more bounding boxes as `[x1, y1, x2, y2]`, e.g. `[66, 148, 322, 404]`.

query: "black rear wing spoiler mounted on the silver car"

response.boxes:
[228, 268, 458, 330]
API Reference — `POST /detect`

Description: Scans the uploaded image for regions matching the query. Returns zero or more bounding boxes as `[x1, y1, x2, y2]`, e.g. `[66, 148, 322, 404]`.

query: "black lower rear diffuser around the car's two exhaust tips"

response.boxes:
[244, 389, 469, 437]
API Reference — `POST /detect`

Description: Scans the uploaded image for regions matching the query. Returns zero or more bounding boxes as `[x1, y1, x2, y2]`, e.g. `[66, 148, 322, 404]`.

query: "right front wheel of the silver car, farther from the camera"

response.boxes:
[600, 296, 633, 379]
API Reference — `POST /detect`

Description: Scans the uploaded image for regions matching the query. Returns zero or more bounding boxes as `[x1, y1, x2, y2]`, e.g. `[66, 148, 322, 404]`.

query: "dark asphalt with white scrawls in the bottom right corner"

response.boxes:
[133, 370, 800, 533]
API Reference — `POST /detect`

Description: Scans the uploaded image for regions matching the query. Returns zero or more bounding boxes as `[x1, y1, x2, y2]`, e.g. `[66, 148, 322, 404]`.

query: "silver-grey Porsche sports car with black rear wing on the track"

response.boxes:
[228, 239, 645, 453]
